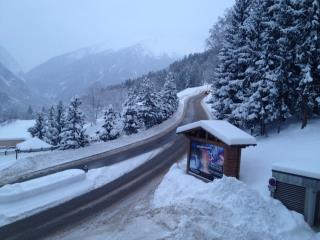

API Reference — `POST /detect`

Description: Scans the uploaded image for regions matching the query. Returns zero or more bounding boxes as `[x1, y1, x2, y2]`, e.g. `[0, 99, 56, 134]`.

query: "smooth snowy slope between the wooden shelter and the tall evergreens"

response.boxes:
[202, 95, 320, 196]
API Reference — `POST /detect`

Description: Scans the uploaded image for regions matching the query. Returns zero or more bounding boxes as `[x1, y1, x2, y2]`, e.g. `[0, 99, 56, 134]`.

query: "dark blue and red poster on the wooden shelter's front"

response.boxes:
[188, 140, 224, 180]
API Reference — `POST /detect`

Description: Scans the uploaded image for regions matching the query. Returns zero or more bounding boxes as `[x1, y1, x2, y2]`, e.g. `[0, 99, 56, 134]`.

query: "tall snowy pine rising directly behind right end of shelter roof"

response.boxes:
[233, 0, 278, 135]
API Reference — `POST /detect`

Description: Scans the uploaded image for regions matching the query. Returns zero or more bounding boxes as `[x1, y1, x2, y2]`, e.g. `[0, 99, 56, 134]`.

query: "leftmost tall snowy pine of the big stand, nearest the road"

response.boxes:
[212, 0, 252, 124]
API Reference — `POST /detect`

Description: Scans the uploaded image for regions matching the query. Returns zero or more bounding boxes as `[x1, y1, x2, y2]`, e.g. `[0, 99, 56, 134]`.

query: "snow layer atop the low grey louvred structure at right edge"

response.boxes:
[272, 158, 320, 180]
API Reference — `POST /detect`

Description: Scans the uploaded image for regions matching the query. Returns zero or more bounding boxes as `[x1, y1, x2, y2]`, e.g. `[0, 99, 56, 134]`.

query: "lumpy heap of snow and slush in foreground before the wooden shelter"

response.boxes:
[50, 157, 320, 240]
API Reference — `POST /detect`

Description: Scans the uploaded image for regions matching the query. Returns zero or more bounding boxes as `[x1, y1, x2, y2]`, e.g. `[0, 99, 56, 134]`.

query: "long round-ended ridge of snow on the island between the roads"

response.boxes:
[0, 169, 86, 204]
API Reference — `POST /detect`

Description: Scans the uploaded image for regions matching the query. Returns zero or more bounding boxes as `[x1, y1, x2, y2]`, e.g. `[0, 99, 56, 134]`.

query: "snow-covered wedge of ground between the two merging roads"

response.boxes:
[0, 145, 169, 226]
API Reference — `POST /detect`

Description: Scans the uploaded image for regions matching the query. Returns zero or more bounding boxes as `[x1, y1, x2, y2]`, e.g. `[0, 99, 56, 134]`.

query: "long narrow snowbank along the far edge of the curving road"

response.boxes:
[0, 86, 207, 181]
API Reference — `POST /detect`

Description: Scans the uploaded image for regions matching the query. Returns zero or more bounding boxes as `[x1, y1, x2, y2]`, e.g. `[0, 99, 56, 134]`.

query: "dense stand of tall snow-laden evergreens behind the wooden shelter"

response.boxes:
[211, 0, 320, 135]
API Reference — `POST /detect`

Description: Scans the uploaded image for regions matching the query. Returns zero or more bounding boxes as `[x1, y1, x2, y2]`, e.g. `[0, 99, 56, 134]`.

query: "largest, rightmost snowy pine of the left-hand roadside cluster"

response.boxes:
[60, 96, 89, 149]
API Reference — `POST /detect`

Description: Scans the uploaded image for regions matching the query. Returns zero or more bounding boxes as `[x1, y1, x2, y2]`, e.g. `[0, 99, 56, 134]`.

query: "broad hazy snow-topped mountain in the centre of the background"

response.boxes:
[26, 44, 174, 101]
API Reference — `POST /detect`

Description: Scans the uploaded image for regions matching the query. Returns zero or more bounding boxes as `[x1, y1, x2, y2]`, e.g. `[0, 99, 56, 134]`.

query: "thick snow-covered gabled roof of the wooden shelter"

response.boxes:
[177, 120, 257, 145]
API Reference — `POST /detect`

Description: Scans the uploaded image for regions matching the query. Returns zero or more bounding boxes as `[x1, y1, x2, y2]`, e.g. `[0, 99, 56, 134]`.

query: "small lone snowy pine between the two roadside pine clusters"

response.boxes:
[99, 105, 120, 142]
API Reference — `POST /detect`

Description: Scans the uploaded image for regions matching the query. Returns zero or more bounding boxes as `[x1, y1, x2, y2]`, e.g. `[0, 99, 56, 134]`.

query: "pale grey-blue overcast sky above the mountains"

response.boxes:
[0, 0, 234, 70]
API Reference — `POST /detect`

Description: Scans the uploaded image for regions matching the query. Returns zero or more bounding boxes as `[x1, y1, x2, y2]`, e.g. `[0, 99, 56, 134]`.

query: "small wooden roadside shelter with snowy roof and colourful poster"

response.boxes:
[176, 120, 256, 180]
